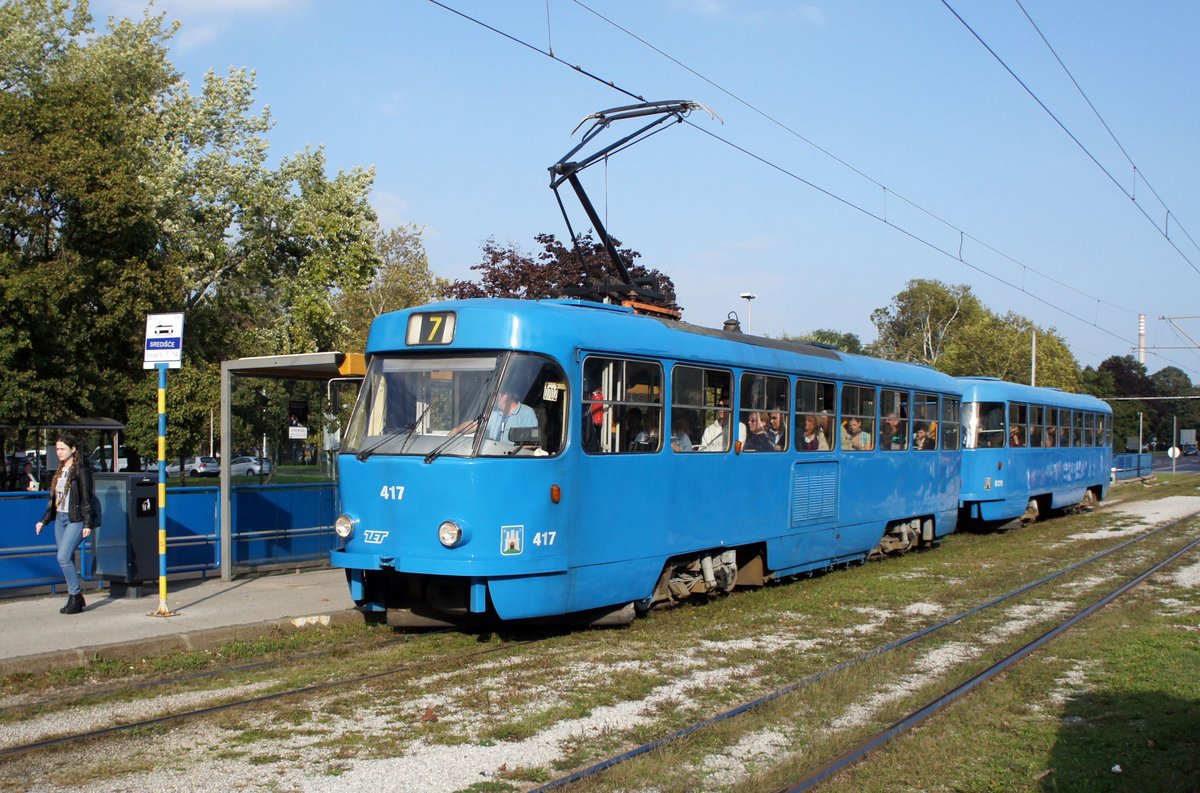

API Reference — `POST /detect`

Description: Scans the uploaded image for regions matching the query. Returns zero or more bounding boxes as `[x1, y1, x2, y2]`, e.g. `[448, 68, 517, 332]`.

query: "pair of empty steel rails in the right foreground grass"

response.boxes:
[533, 518, 1200, 793]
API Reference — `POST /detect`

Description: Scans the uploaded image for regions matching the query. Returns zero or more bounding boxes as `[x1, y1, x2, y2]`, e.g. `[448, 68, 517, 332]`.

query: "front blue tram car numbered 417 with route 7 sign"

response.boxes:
[331, 299, 964, 626]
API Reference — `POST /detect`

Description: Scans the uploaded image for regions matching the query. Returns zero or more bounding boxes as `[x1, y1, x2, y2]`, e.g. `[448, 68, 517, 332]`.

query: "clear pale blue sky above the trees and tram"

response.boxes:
[91, 0, 1200, 383]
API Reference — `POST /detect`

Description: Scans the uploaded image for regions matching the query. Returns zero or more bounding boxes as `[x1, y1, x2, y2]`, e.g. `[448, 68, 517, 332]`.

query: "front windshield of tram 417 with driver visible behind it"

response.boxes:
[342, 353, 568, 462]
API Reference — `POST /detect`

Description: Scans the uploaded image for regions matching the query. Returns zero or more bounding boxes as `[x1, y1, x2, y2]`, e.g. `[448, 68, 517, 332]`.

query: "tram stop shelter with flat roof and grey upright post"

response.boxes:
[220, 353, 366, 581]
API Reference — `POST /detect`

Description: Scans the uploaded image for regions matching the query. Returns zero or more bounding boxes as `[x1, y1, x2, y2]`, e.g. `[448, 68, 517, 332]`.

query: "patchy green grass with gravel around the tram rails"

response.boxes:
[0, 475, 1200, 793]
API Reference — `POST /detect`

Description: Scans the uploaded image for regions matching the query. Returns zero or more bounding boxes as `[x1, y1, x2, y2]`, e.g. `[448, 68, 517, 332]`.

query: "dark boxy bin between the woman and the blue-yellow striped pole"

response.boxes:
[91, 473, 158, 597]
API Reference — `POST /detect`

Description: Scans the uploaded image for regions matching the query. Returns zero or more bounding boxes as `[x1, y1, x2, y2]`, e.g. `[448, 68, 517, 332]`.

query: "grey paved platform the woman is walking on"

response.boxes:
[0, 569, 362, 674]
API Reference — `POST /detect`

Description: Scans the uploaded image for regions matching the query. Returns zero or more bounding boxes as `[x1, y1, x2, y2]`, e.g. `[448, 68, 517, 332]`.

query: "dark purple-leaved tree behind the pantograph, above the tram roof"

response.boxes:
[444, 233, 676, 306]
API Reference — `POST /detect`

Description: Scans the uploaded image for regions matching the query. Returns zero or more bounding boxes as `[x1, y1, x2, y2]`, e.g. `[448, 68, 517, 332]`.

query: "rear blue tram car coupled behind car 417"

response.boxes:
[959, 377, 1112, 523]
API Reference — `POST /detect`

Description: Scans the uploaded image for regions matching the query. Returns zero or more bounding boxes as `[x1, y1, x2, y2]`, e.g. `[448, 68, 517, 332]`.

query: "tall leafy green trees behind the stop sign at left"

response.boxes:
[0, 0, 384, 453]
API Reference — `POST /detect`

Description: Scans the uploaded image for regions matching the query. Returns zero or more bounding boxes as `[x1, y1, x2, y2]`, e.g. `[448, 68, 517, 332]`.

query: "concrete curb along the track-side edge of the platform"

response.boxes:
[0, 608, 366, 677]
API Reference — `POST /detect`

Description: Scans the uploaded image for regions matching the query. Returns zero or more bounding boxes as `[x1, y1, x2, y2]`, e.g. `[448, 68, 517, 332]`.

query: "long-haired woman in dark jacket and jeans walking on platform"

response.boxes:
[34, 434, 94, 614]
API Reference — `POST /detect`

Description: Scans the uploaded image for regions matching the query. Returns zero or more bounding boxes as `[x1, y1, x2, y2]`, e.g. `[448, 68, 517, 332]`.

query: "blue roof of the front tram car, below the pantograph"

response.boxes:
[366, 298, 962, 394]
